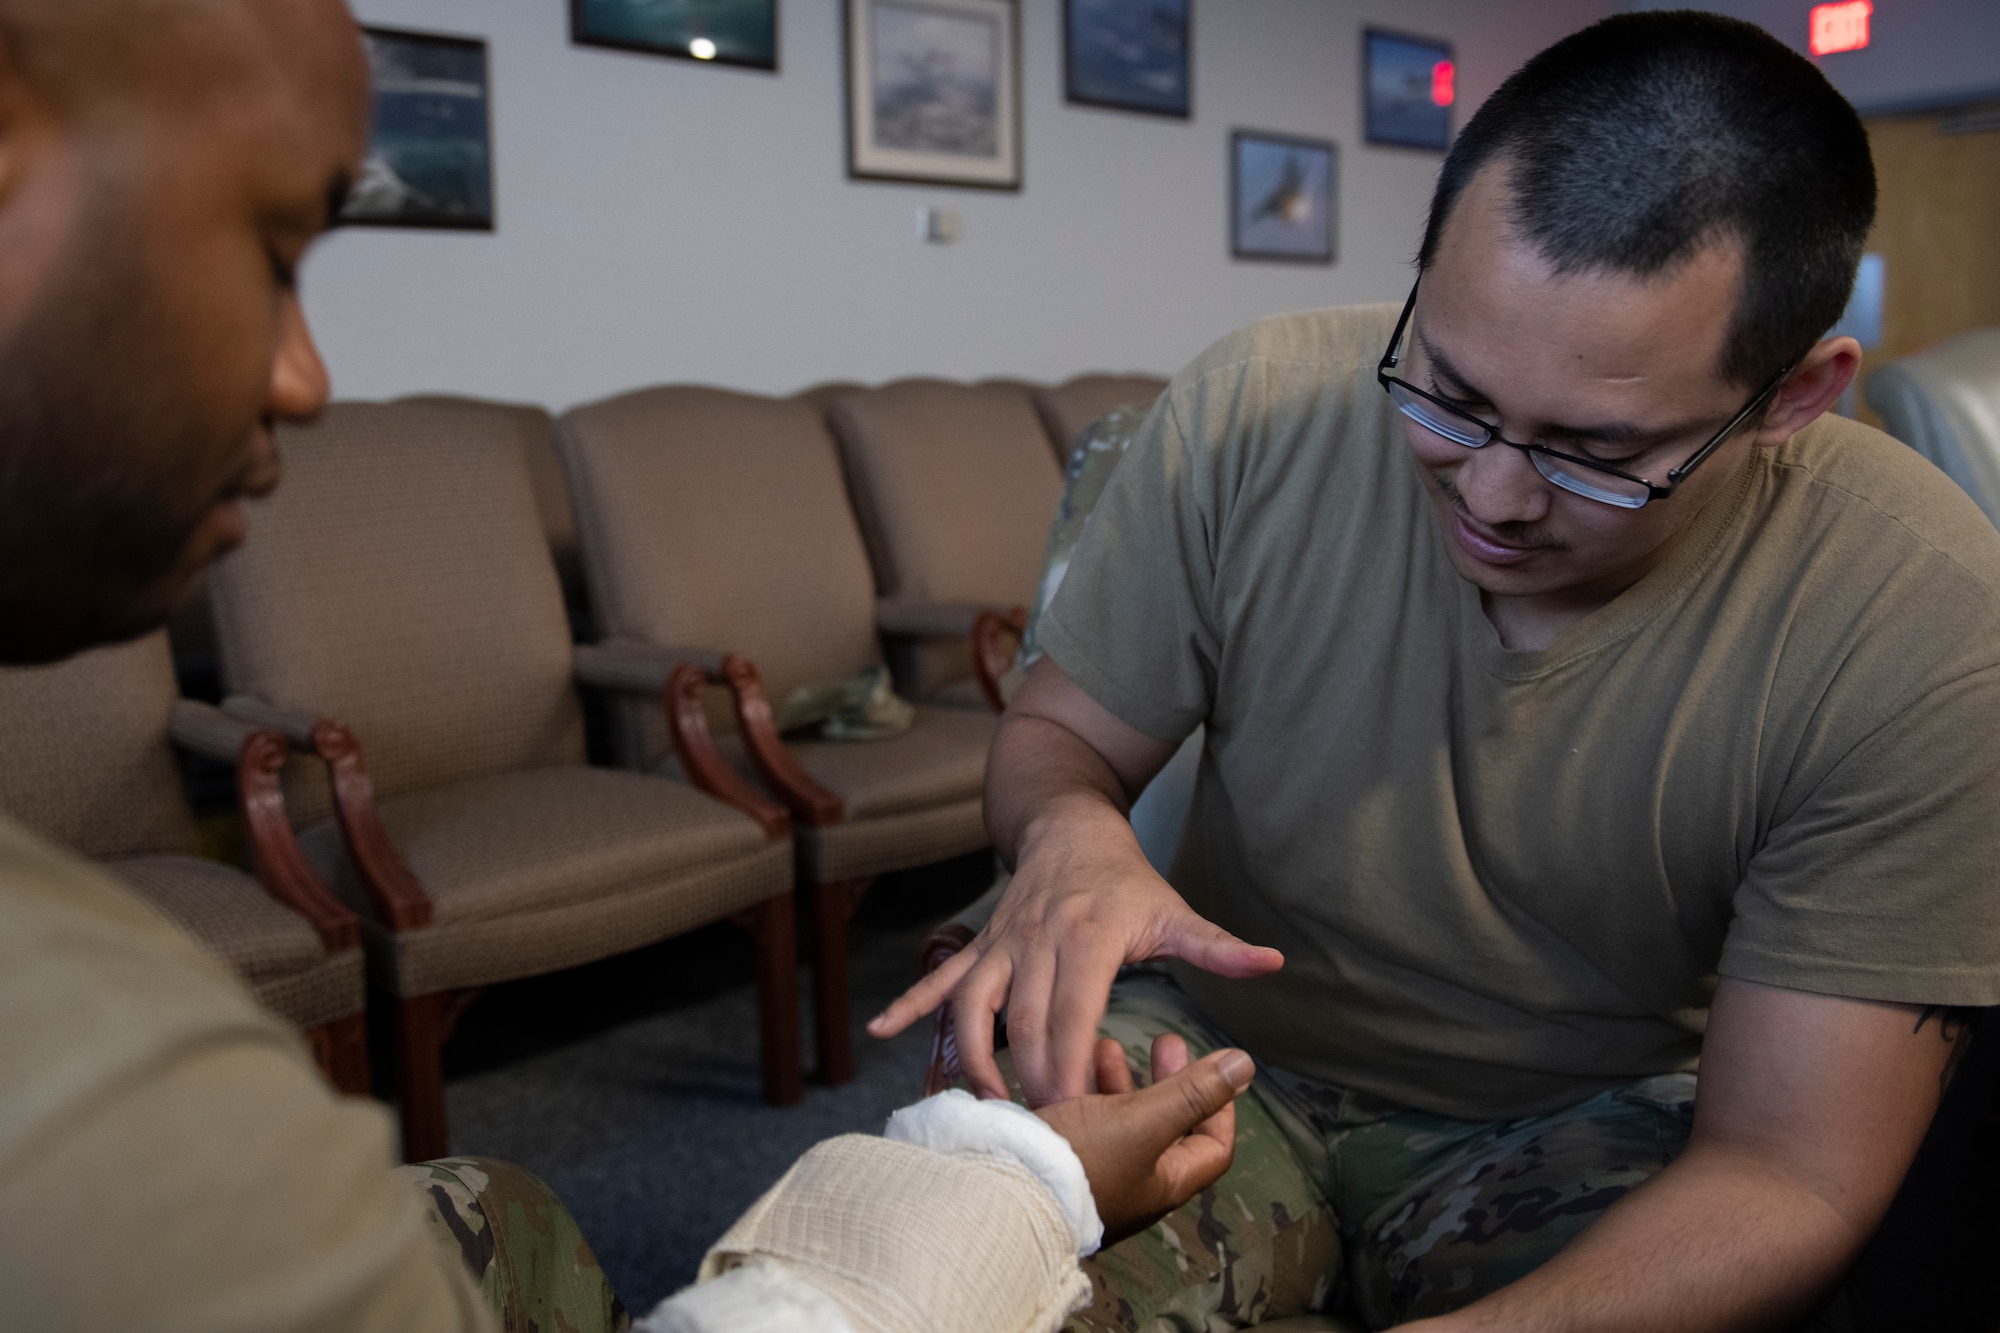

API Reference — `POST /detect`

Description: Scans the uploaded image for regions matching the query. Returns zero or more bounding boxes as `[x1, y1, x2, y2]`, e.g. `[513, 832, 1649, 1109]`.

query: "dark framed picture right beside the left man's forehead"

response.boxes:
[340, 28, 494, 232]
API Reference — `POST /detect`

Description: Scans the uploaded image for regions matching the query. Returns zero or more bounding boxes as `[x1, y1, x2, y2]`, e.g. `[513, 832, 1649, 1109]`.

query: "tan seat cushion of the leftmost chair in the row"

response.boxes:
[104, 857, 368, 1029]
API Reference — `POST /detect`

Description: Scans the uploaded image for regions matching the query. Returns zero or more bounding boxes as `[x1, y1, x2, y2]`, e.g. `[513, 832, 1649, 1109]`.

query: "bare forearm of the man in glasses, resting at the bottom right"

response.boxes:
[1406, 1147, 1874, 1333]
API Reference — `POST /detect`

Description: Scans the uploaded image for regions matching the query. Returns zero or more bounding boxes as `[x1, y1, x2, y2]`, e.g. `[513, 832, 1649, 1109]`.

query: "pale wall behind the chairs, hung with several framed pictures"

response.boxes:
[304, 0, 1622, 408]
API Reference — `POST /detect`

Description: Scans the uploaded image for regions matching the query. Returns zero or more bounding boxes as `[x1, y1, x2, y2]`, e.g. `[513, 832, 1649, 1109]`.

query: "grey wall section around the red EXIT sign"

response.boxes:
[1632, 0, 2000, 114]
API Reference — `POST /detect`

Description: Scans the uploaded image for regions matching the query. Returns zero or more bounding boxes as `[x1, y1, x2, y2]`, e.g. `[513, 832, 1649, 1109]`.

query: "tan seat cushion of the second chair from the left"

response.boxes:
[300, 765, 766, 925]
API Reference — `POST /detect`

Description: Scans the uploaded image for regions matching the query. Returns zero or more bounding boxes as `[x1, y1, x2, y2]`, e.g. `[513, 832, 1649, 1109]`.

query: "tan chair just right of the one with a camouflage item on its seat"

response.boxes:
[828, 380, 1062, 709]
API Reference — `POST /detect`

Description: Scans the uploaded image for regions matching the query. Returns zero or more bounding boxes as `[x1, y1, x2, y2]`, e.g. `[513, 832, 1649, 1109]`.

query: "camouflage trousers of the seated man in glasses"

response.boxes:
[1068, 977, 1694, 1333]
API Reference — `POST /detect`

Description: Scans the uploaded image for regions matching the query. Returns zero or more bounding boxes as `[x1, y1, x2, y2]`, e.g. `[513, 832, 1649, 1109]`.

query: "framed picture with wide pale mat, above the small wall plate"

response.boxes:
[848, 0, 1020, 190]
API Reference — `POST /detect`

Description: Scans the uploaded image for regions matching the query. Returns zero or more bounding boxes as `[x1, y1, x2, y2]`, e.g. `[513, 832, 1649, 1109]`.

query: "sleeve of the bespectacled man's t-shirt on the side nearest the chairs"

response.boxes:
[1040, 384, 1220, 743]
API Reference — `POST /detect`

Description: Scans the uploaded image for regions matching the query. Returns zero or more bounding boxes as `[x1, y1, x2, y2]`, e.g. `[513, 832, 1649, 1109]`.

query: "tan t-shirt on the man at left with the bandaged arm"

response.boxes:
[0, 819, 492, 1333]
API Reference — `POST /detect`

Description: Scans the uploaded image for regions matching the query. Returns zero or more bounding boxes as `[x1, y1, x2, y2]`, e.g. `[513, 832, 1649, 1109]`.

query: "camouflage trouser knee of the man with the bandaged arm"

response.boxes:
[396, 1157, 632, 1333]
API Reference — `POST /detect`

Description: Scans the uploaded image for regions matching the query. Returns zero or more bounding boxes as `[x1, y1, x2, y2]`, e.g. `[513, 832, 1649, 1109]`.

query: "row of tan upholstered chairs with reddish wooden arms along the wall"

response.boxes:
[0, 376, 1160, 1159]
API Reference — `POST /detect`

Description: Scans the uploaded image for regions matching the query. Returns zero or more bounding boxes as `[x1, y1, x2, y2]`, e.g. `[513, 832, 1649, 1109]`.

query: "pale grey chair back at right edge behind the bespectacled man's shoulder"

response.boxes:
[1868, 328, 2000, 524]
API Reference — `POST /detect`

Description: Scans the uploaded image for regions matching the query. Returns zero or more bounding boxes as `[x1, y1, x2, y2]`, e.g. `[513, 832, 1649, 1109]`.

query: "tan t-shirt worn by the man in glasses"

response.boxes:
[1042, 306, 2000, 1119]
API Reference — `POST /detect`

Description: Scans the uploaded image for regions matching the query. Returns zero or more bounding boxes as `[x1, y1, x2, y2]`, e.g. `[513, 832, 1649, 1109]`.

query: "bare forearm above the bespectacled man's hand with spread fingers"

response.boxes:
[986, 713, 1136, 867]
